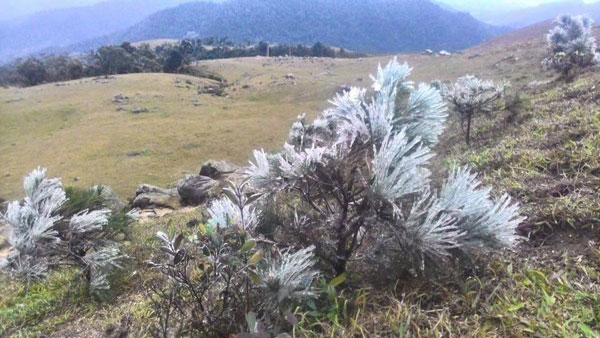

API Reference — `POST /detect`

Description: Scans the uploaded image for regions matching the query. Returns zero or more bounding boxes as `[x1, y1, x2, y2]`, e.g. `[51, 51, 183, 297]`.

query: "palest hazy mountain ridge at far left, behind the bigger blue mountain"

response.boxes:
[0, 0, 200, 62]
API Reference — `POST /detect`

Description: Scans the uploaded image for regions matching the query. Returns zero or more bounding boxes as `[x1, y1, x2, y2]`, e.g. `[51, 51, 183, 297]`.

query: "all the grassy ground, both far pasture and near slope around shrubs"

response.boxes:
[0, 25, 600, 337]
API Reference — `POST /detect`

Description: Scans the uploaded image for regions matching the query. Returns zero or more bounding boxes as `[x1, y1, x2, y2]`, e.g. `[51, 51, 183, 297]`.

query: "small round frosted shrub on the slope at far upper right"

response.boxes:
[542, 15, 600, 79]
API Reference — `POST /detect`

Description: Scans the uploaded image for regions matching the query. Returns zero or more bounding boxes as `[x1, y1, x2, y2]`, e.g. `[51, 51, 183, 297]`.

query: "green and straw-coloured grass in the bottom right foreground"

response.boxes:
[295, 247, 600, 337]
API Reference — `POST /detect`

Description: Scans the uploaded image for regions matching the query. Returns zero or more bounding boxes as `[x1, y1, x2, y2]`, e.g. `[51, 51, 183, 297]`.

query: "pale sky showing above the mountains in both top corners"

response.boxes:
[0, 0, 599, 20]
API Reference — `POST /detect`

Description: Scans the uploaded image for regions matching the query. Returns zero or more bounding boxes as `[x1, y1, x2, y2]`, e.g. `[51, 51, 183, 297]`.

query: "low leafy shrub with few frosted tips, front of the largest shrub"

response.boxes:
[148, 184, 318, 337]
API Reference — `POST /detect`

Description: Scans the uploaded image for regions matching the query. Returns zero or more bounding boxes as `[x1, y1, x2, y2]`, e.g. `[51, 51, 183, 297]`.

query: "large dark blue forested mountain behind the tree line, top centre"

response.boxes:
[73, 0, 503, 52]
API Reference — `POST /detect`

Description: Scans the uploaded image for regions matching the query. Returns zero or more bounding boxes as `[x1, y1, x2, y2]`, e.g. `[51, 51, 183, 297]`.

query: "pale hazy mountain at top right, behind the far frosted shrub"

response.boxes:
[478, 0, 600, 28]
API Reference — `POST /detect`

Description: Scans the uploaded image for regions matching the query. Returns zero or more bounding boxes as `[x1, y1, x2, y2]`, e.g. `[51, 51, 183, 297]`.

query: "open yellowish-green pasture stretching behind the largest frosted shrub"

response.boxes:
[0, 23, 546, 199]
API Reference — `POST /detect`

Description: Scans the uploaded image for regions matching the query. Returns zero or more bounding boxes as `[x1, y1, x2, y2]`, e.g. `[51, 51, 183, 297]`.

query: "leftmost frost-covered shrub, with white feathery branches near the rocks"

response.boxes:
[0, 168, 124, 294]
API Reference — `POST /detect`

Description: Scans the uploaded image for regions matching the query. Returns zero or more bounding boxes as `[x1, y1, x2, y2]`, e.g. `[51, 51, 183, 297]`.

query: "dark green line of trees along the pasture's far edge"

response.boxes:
[0, 37, 363, 86]
